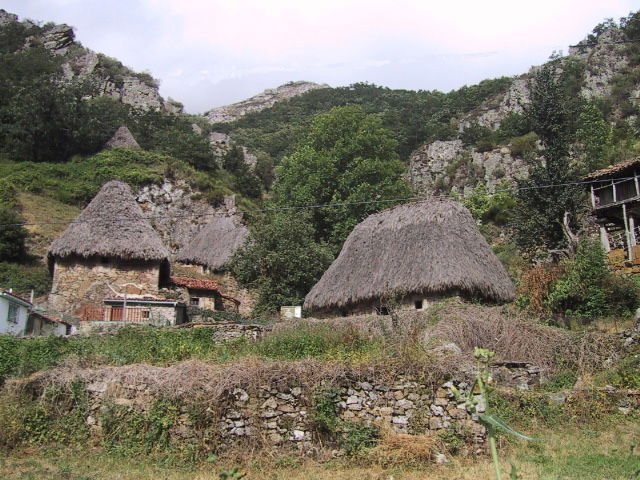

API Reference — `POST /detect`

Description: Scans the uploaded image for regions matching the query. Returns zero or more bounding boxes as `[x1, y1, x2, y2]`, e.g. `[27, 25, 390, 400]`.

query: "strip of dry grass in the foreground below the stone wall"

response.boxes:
[0, 417, 640, 480]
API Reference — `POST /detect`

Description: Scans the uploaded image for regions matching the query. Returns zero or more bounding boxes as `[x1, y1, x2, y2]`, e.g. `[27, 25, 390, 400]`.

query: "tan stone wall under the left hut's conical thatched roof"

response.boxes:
[49, 257, 160, 314]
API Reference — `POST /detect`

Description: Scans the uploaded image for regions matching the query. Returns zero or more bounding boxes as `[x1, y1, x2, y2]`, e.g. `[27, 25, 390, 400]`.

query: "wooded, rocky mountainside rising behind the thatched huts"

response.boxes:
[0, 7, 640, 318]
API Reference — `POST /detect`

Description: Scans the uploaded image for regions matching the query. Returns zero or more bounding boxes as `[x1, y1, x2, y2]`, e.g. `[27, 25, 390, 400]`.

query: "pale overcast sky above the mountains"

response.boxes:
[5, 0, 640, 113]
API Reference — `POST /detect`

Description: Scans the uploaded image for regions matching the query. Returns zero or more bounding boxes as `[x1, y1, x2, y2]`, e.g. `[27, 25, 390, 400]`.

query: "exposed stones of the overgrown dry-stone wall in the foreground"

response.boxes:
[86, 377, 486, 453]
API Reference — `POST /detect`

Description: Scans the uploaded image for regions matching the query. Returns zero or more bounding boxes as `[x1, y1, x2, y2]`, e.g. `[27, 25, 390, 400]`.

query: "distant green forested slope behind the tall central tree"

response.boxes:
[214, 77, 512, 163]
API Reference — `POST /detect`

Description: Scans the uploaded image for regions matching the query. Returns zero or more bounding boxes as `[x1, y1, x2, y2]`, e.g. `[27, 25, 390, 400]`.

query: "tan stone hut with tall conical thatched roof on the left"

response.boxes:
[47, 180, 169, 314]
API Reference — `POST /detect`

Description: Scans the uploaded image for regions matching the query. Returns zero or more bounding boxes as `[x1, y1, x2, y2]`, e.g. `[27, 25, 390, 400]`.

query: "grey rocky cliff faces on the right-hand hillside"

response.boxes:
[409, 25, 640, 194]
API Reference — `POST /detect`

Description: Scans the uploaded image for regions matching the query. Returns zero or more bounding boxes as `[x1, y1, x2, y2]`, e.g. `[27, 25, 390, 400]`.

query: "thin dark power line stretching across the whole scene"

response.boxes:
[0, 177, 635, 227]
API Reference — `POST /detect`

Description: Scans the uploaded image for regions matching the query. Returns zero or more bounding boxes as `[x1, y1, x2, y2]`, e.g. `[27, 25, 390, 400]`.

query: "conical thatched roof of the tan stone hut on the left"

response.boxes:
[48, 180, 169, 261]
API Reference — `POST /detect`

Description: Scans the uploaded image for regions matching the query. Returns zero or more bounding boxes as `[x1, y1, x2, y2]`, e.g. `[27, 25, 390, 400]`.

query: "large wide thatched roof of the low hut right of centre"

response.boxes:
[304, 200, 515, 310]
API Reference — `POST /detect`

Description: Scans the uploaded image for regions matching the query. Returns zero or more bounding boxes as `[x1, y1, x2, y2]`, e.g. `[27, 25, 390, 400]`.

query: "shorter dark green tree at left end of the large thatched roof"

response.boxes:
[231, 212, 333, 312]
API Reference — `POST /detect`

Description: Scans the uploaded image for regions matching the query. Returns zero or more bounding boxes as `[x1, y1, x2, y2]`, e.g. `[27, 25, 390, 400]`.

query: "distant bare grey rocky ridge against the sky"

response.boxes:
[204, 81, 329, 123]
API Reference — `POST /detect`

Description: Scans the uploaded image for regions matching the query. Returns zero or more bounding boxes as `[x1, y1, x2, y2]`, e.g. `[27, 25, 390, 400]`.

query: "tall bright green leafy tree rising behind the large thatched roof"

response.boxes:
[273, 107, 411, 248]
